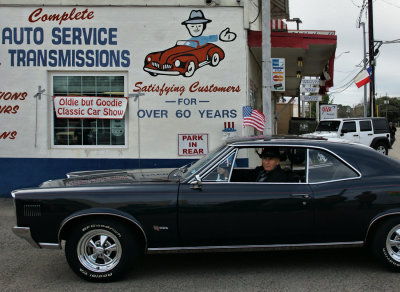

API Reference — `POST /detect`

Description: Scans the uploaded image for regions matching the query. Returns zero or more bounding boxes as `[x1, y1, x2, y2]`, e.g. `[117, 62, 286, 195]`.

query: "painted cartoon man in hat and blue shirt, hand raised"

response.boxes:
[182, 10, 236, 46]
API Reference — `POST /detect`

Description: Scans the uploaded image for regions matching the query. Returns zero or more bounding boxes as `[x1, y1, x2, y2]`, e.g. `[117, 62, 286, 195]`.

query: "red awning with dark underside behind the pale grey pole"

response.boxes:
[248, 30, 337, 96]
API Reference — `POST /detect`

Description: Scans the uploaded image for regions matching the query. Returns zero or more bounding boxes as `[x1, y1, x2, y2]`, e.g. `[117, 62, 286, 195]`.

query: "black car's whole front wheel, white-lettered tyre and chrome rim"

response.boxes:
[65, 220, 139, 282]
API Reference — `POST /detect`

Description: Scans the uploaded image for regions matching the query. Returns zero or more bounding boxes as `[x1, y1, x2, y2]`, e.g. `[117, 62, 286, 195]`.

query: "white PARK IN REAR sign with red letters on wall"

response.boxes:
[178, 134, 208, 156]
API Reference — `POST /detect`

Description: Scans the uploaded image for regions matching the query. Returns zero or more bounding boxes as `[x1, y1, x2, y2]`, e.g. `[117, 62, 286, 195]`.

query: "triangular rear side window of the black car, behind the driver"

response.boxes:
[308, 149, 359, 183]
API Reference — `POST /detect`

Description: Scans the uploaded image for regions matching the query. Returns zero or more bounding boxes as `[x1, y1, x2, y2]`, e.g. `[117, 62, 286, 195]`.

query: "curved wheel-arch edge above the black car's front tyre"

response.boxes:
[58, 208, 147, 250]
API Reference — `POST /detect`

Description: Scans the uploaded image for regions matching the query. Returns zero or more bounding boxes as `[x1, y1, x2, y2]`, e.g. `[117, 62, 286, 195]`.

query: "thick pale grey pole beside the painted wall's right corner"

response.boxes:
[262, 0, 273, 136]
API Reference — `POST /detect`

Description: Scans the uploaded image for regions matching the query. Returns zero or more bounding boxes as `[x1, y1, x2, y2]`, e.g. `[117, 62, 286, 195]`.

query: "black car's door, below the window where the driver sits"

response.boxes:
[178, 146, 314, 246]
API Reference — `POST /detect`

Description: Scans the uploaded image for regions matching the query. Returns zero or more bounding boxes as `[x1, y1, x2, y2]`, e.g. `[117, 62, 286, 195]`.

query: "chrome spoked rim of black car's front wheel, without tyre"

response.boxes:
[77, 229, 122, 273]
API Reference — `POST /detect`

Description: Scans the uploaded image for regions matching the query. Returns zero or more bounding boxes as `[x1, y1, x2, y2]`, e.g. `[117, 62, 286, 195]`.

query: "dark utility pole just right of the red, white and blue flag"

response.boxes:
[368, 0, 375, 117]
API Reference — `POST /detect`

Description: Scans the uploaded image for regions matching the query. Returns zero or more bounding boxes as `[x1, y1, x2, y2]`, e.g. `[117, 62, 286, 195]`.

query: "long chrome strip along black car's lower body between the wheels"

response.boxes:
[147, 241, 364, 254]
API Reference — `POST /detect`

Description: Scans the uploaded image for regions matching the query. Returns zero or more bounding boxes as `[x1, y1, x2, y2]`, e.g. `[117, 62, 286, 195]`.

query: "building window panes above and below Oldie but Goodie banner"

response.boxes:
[52, 74, 126, 146]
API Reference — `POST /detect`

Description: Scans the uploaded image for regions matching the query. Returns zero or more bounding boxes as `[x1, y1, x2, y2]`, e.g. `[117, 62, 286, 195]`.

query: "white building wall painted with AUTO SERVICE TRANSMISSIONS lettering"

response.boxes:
[0, 5, 245, 159]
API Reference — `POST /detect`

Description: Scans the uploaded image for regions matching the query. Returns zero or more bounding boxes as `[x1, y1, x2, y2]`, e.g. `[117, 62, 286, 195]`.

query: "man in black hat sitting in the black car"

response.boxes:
[255, 147, 295, 182]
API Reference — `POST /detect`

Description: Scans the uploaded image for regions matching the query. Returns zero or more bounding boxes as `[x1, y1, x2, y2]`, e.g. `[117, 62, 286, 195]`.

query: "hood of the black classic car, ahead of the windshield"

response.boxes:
[40, 168, 174, 188]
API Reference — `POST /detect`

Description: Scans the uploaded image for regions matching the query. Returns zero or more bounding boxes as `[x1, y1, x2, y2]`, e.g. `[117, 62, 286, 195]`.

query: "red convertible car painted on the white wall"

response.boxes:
[143, 40, 225, 77]
